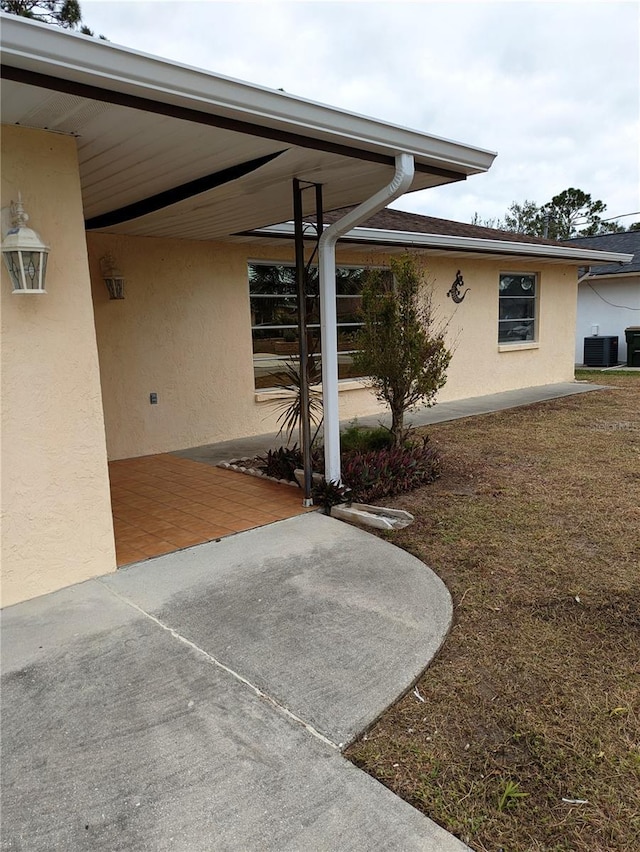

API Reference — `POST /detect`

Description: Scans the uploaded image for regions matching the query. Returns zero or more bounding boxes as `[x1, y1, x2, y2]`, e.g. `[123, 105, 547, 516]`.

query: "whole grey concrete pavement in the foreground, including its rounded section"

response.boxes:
[2, 513, 466, 852]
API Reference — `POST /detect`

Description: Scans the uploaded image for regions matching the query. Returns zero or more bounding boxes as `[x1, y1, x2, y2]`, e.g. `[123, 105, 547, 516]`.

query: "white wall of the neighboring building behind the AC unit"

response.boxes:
[575, 275, 640, 364]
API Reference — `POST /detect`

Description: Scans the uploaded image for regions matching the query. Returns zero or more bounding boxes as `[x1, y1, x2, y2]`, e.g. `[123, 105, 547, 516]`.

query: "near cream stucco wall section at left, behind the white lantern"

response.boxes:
[1, 127, 115, 605]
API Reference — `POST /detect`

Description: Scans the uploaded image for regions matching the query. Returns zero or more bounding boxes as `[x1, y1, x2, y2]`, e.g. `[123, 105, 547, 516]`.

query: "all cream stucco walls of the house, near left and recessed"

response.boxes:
[1, 127, 576, 605]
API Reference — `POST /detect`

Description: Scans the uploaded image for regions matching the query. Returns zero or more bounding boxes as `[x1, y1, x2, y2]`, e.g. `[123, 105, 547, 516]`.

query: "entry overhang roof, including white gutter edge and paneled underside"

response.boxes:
[1, 15, 495, 239]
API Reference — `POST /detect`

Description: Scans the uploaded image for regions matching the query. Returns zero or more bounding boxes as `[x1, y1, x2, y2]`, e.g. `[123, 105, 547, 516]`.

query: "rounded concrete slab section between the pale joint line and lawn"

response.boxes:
[101, 513, 452, 746]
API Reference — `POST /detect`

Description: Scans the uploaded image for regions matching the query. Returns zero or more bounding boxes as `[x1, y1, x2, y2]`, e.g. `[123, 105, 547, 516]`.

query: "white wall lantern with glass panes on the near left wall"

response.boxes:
[2, 195, 49, 293]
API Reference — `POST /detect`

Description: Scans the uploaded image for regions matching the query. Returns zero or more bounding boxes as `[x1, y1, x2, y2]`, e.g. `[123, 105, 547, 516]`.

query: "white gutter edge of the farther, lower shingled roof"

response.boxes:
[253, 222, 633, 264]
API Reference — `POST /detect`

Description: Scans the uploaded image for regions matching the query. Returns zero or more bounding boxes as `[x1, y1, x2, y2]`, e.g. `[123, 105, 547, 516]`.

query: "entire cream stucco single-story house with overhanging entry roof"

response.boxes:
[0, 16, 628, 605]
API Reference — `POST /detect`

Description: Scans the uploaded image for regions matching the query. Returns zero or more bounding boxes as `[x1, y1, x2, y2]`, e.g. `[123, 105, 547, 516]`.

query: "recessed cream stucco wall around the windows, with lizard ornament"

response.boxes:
[88, 233, 576, 459]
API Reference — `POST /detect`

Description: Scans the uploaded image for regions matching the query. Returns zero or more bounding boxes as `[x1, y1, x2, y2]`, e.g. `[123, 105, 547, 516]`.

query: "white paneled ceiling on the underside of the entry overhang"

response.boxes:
[2, 81, 454, 239]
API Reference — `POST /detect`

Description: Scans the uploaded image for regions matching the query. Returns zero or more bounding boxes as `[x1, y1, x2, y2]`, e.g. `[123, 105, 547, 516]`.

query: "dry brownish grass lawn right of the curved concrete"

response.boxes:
[347, 373, 640, 852]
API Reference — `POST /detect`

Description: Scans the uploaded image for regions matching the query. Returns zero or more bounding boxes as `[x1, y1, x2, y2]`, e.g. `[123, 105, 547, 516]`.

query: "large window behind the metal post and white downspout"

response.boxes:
[249, 263, 380, 388]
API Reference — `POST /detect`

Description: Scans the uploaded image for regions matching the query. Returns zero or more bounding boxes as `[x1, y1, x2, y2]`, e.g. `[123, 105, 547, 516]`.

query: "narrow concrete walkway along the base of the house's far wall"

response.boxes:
[174, 382, 606, 464]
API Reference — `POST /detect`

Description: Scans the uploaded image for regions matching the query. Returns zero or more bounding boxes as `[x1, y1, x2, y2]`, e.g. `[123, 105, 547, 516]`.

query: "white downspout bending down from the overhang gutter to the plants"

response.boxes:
[318, 154, 414, 482]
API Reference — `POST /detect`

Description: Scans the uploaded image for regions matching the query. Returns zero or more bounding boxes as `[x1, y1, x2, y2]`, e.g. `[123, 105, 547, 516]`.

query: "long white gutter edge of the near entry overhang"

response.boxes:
[0, 14, 496, 175]
